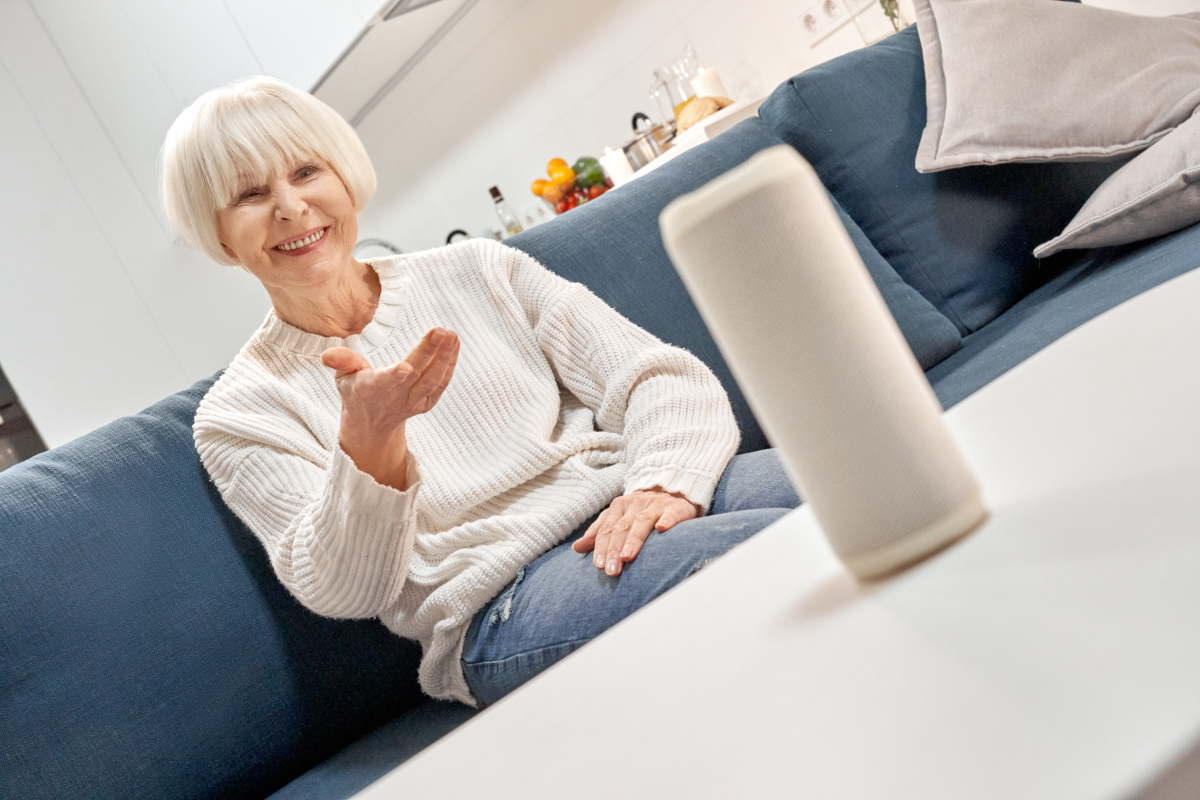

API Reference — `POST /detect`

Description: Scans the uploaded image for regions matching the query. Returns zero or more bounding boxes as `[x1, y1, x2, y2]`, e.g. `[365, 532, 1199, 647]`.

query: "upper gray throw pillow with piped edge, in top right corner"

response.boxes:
[914, 0, 1200, 173]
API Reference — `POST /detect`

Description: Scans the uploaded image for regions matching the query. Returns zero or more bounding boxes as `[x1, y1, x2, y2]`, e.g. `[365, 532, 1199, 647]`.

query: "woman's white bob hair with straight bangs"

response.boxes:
[162, 77, 376, 265]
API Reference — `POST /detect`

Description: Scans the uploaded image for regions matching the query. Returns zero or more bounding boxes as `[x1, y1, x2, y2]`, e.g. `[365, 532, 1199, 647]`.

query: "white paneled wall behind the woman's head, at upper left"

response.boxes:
[0, 0, 376, 446]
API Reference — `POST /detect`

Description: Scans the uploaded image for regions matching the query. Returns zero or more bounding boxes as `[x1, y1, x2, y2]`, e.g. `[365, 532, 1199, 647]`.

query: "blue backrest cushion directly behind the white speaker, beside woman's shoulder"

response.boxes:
[505, 118, 961, 452]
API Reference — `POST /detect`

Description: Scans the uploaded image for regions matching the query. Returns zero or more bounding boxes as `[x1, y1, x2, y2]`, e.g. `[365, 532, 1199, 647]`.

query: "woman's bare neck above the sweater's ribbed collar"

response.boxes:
[266, 259, 382, 338]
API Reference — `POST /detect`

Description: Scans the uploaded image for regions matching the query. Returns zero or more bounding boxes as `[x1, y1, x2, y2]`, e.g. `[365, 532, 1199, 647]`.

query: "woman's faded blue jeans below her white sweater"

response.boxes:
[462, 450, 800, 705]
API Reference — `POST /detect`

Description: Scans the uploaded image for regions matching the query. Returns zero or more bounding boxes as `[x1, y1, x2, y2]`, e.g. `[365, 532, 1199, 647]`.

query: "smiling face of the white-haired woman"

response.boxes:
[217, 161, 359, 290]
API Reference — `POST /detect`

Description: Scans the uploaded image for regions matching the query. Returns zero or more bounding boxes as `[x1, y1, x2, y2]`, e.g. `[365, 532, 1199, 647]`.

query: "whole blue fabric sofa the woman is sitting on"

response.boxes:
[0, 18, 1200, 799]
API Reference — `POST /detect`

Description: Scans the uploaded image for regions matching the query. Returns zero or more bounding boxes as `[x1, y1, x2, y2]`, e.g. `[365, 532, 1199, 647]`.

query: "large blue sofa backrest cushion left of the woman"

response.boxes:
[0, 379, 421, 799]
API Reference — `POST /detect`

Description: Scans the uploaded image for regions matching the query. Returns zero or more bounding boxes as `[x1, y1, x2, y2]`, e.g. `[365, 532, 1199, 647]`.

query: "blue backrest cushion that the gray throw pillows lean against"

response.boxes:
[758, 13, 1122, 335]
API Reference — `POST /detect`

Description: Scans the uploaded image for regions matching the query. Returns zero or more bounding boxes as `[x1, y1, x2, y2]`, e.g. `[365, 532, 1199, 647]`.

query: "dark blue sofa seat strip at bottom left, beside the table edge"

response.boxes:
[269, 698, 479, 800]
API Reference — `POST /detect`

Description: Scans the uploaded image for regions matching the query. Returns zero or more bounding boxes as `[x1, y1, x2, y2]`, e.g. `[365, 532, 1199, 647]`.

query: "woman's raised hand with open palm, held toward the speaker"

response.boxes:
[320, 327, 458, 492]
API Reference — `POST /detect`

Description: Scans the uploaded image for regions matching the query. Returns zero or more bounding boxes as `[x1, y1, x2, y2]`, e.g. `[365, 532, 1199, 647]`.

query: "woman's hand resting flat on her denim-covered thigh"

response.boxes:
[571, 487, 698, 576]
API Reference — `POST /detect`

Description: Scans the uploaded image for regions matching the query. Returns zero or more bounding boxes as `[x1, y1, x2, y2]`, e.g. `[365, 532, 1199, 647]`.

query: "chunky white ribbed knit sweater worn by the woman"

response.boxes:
[194, 240, 738, 703]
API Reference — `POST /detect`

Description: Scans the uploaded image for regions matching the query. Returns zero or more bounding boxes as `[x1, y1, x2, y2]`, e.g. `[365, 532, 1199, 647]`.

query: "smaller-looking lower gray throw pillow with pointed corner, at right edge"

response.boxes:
[1033, 113, 1200, 258]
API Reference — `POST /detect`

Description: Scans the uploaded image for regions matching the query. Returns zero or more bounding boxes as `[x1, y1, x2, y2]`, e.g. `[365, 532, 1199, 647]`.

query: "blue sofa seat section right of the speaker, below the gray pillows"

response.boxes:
[926, 224, 1200, 408]
